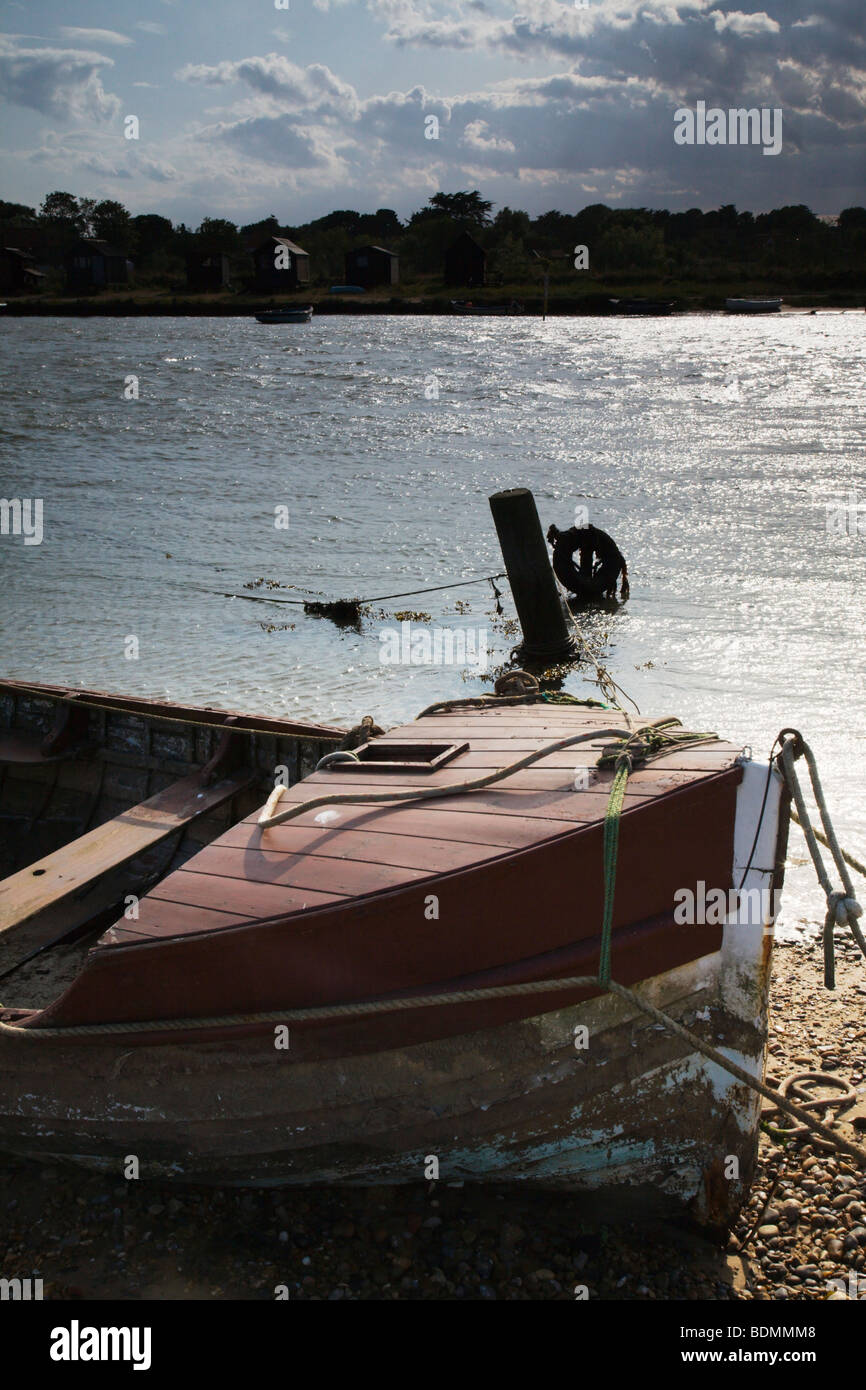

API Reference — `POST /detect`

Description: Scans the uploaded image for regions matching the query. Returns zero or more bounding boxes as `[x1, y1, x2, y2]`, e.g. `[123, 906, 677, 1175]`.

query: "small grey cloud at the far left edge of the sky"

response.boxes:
[0, 36, 121, 121]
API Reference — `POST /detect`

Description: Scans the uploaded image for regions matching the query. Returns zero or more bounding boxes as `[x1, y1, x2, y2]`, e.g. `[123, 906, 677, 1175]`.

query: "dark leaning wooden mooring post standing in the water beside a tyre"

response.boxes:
[489, 488, 575, 662]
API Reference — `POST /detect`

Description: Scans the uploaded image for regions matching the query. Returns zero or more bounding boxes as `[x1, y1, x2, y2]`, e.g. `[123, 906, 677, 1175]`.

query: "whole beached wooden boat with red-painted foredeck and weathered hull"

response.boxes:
[0, 681, 788, 1229]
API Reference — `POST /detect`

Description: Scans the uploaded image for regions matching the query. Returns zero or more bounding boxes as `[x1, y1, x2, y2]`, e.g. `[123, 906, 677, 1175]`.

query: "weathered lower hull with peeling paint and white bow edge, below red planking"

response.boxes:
[0, 765, 787, 1232]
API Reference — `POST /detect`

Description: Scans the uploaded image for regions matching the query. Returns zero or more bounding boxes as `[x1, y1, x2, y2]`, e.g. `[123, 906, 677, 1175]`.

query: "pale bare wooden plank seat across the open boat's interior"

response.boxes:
[0, 773, 252, 931]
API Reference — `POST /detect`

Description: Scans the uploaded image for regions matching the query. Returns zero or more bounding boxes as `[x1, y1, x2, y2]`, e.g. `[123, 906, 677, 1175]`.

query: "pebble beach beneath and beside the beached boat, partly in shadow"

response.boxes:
[0, 929, 866, 1301]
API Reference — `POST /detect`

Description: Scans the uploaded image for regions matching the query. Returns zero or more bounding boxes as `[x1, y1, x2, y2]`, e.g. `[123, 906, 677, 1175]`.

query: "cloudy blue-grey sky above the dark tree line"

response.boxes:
[0, 0, 866, 227]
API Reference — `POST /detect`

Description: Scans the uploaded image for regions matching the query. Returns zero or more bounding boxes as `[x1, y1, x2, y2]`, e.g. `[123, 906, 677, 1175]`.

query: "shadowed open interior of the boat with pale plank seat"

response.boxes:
[0, 681, 345, 1008]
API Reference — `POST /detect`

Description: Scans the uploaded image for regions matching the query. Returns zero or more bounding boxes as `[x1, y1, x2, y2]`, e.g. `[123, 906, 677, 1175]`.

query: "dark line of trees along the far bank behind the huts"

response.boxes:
[0, 189, 866, 288]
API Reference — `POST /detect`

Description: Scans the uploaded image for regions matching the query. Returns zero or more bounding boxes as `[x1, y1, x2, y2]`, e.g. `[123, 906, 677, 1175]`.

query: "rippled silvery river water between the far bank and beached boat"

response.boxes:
[0, 313, 866, 919]
